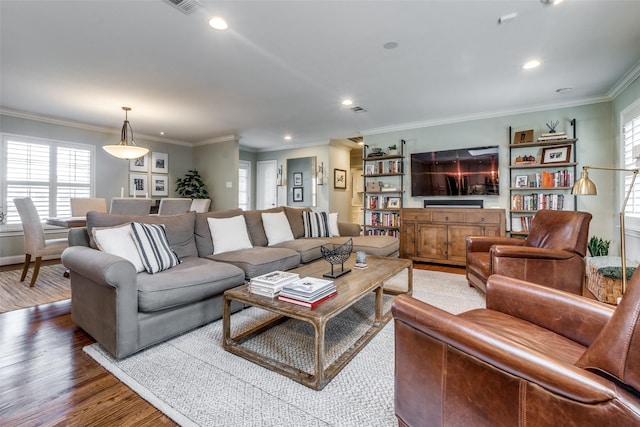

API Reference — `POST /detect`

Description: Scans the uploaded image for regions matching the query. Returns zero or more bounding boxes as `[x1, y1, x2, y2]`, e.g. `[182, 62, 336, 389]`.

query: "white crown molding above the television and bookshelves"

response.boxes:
[360, 96, 612, 136]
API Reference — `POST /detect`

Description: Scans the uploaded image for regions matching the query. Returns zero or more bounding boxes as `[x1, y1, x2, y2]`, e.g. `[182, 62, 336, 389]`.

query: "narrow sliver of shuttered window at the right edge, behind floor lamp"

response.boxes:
[622, 101, 640, 214]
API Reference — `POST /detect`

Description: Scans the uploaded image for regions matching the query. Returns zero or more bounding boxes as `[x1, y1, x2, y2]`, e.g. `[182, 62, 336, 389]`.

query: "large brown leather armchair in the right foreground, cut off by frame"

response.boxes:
[392, 270, 640, 426]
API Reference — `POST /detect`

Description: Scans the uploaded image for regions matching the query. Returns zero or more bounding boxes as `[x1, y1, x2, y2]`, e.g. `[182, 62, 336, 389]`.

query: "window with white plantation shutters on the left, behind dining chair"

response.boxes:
[1, 136, 95, 224]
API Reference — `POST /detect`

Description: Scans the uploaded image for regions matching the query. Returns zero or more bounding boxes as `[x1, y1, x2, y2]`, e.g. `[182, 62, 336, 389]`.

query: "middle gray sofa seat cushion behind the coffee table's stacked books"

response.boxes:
[207, 246, 300, 279]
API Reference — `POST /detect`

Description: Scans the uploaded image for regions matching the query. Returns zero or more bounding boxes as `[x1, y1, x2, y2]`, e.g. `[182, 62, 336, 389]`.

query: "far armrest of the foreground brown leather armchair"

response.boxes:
[487, 274, 614, 346]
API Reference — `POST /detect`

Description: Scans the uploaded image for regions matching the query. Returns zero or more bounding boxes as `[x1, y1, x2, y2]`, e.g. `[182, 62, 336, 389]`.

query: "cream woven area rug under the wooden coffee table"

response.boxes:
[84, 270, 485, 427]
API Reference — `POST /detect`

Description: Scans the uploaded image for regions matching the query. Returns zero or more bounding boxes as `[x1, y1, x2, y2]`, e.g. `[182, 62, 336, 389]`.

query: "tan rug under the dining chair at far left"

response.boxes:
[0, 264, 71, 313]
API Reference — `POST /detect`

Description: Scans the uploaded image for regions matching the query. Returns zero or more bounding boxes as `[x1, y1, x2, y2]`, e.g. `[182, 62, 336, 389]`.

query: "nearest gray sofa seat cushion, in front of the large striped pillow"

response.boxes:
[138, 258, 244, 312]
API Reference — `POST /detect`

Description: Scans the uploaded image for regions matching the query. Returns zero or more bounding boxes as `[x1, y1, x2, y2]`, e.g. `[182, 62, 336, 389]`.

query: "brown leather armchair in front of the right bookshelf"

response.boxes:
[466, 210, 591, 295]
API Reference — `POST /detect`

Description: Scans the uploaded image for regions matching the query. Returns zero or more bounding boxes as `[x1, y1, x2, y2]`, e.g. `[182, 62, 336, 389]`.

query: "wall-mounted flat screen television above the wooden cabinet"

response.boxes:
[411, 145, 500, 197]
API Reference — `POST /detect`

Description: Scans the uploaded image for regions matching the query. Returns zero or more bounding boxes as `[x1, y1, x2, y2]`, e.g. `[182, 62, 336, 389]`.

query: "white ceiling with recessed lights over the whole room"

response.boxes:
[0, 0, 640, 150]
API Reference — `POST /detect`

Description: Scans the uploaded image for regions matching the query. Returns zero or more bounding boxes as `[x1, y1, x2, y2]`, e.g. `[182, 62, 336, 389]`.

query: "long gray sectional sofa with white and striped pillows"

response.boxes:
[62, 207, 399, 359]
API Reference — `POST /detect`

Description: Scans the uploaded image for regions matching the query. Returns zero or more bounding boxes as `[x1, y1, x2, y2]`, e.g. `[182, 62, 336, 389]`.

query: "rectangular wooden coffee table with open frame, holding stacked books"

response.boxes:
[222, 254, 413, 390]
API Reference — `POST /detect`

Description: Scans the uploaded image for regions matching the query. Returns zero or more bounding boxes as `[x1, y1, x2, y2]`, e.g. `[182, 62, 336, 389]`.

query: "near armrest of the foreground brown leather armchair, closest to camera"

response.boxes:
[392, 295, 616, 404]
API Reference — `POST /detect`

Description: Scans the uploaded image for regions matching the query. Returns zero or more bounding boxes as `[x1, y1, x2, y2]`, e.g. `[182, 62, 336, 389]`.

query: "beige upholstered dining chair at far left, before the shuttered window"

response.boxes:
[13, 197, 69, 287]
